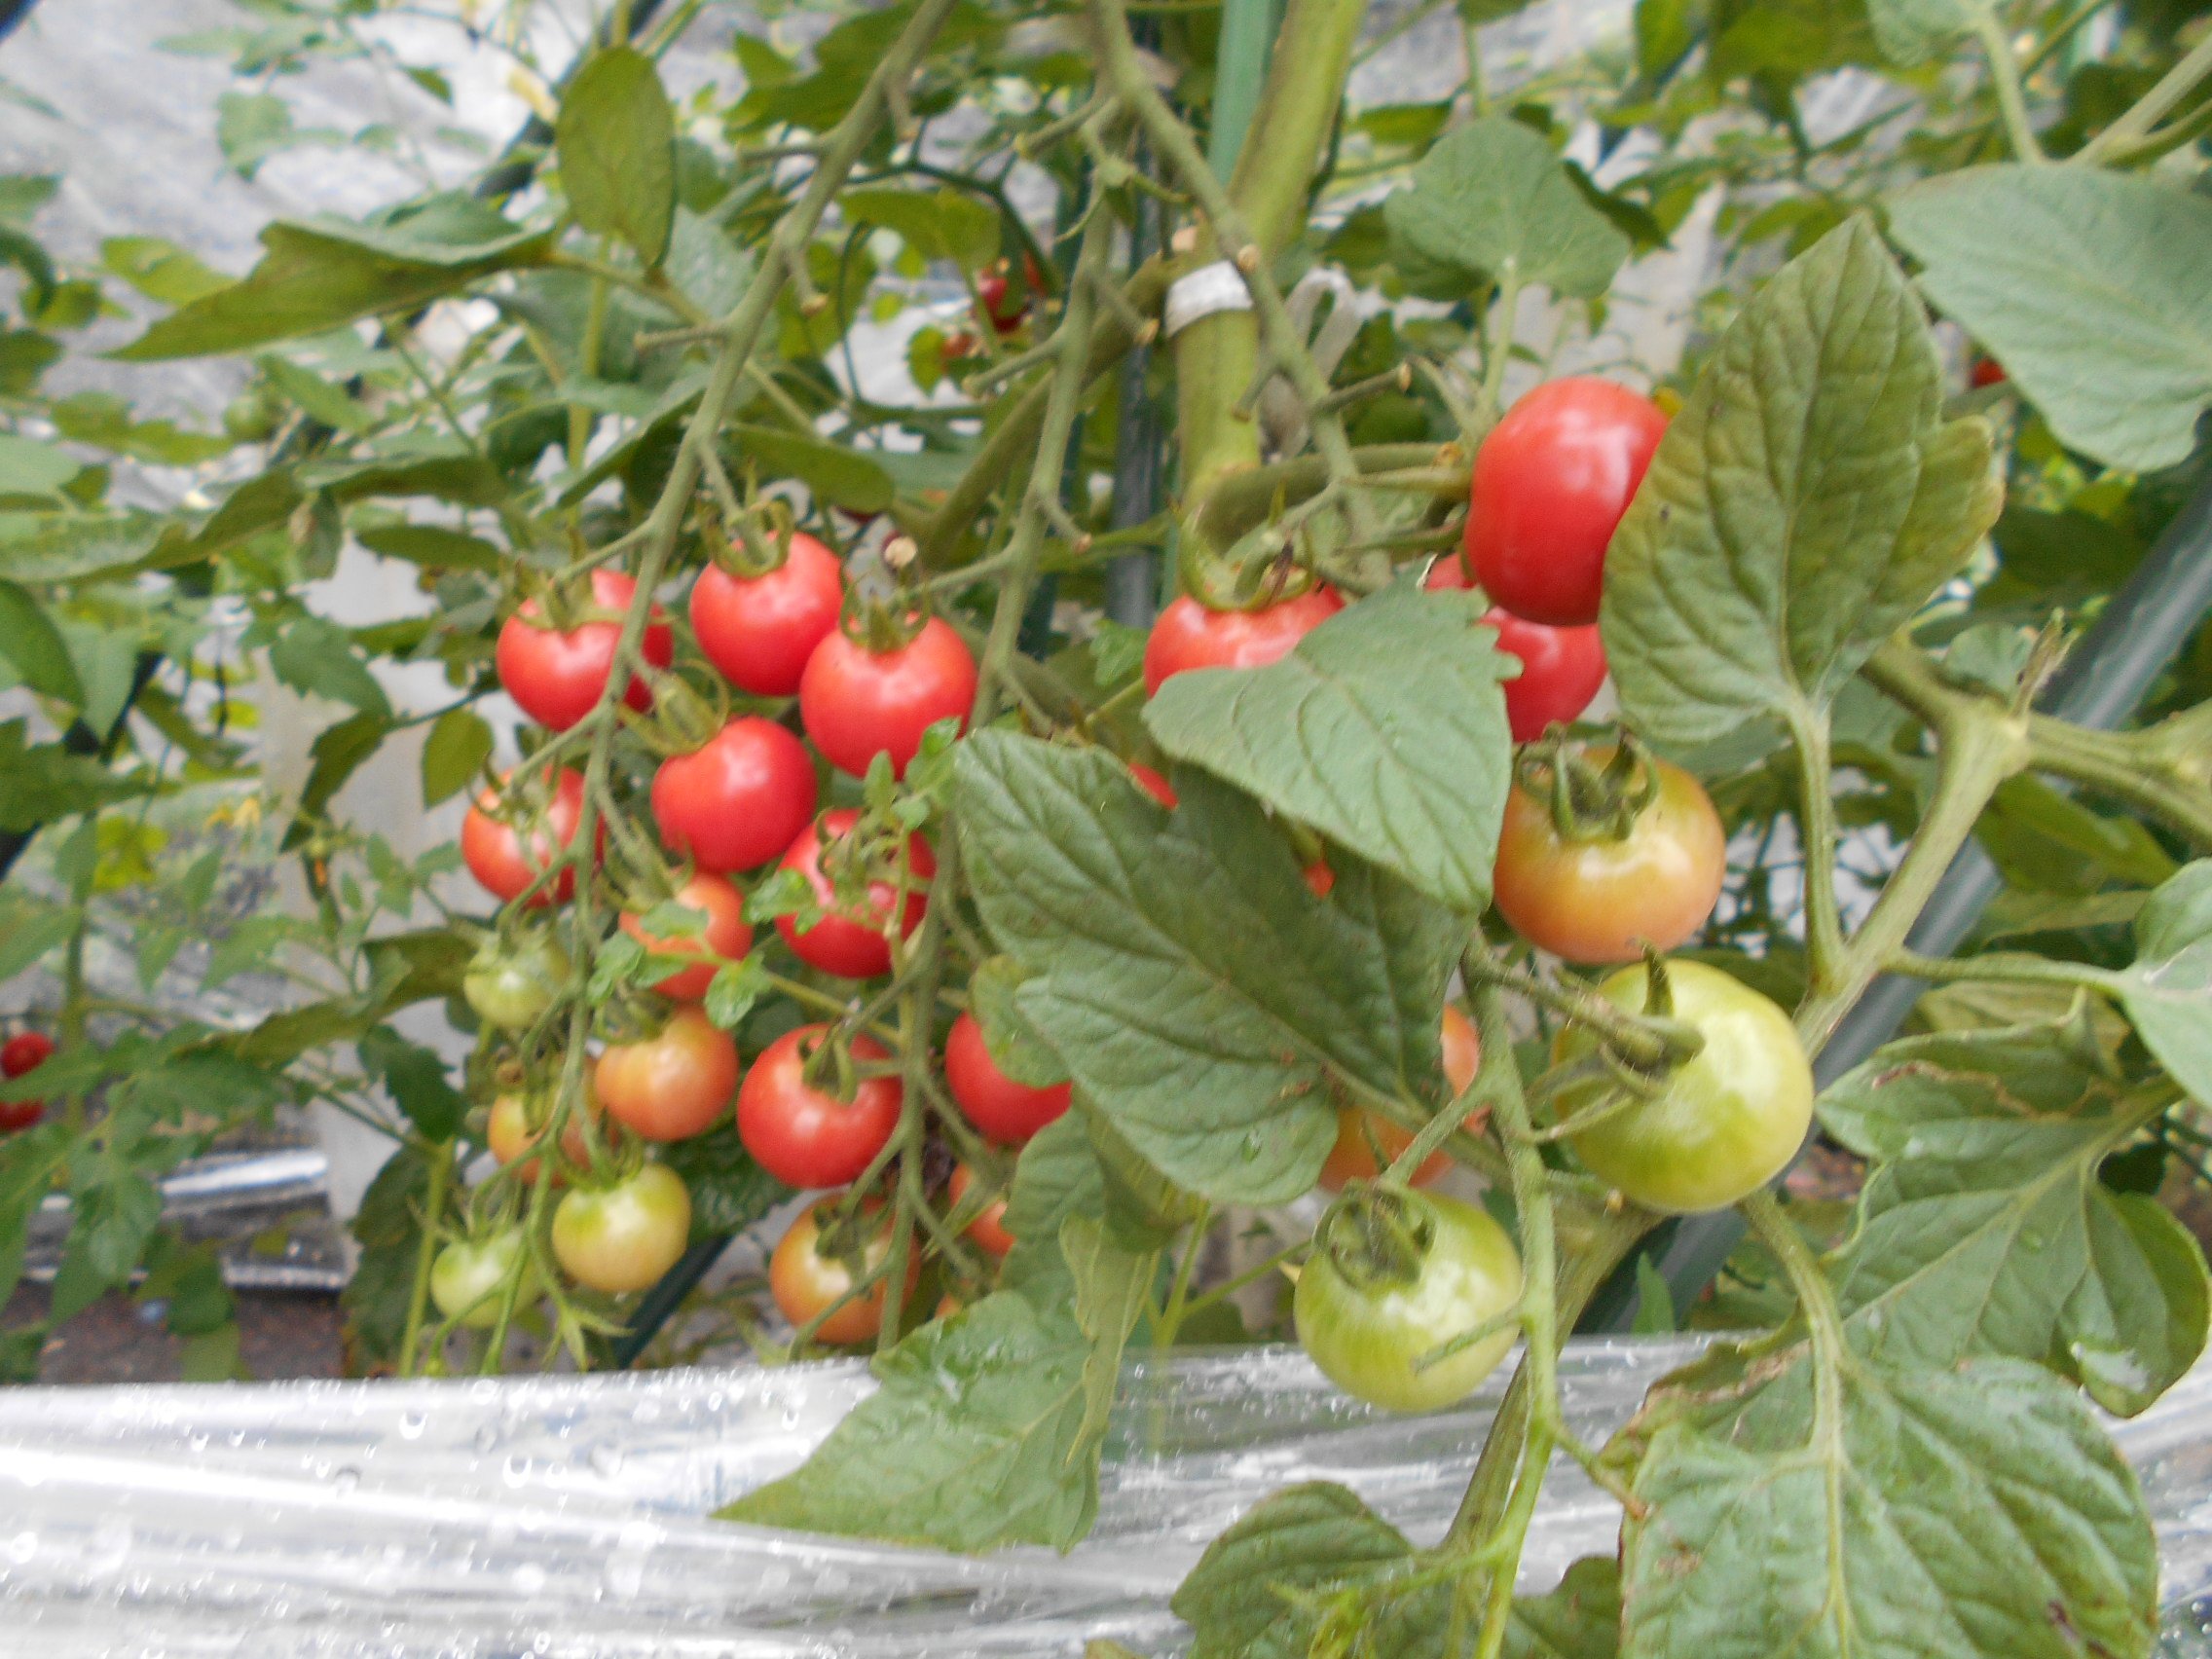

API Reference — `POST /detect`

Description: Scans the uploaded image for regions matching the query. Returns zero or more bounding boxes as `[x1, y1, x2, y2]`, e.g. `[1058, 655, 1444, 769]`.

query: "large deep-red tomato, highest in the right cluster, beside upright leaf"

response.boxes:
[1466, 376, 1666, 628]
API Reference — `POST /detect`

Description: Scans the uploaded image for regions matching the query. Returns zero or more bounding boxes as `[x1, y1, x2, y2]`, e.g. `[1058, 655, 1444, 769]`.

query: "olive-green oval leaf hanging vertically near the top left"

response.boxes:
[553, 47, 677, 266]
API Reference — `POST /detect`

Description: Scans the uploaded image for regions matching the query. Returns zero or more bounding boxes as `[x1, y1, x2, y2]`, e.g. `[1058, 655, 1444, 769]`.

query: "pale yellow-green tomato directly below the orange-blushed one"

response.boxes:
[1553, 962, 1814, 1214]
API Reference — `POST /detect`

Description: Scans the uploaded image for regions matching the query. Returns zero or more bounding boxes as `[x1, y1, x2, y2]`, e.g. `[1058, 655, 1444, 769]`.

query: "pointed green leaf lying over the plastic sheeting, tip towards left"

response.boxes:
[717, 1290, 1099, 1551]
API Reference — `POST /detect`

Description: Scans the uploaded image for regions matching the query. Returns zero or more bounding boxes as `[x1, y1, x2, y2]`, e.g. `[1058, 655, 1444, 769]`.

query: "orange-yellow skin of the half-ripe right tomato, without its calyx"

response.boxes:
[1491, 750, 1727, 965]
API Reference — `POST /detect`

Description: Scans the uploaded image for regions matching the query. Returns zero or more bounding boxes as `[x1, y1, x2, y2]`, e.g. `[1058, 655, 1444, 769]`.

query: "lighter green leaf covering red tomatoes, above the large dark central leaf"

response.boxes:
[1144, 582, 1513, 913]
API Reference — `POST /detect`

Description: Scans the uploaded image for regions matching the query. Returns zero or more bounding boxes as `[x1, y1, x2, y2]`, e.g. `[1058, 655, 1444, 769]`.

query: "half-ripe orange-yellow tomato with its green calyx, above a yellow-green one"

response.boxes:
[1491, 739, 1727, 967]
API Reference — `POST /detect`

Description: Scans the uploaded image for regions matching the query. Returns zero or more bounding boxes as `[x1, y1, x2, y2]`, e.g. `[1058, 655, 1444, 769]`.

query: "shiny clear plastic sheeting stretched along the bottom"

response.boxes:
[13, 1339, 2212, 1659]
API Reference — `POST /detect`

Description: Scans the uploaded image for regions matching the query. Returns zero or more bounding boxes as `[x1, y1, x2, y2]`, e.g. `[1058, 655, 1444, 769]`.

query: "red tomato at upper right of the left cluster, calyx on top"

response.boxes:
[798, 617, 976, 779]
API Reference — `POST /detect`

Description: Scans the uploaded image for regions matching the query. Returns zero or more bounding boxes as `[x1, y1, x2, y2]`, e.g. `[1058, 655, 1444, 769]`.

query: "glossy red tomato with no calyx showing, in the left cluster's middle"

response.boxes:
[652, 715, 816, 876]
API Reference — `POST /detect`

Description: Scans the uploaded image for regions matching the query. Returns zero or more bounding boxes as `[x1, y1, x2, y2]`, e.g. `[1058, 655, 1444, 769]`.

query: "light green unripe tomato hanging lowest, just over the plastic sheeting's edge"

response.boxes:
[1292, 1186, 1522, 1412]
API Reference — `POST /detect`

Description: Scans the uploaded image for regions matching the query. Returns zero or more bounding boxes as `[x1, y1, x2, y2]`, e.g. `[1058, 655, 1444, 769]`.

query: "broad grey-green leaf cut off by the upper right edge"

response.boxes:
[1889, 166, 2212, 471]
